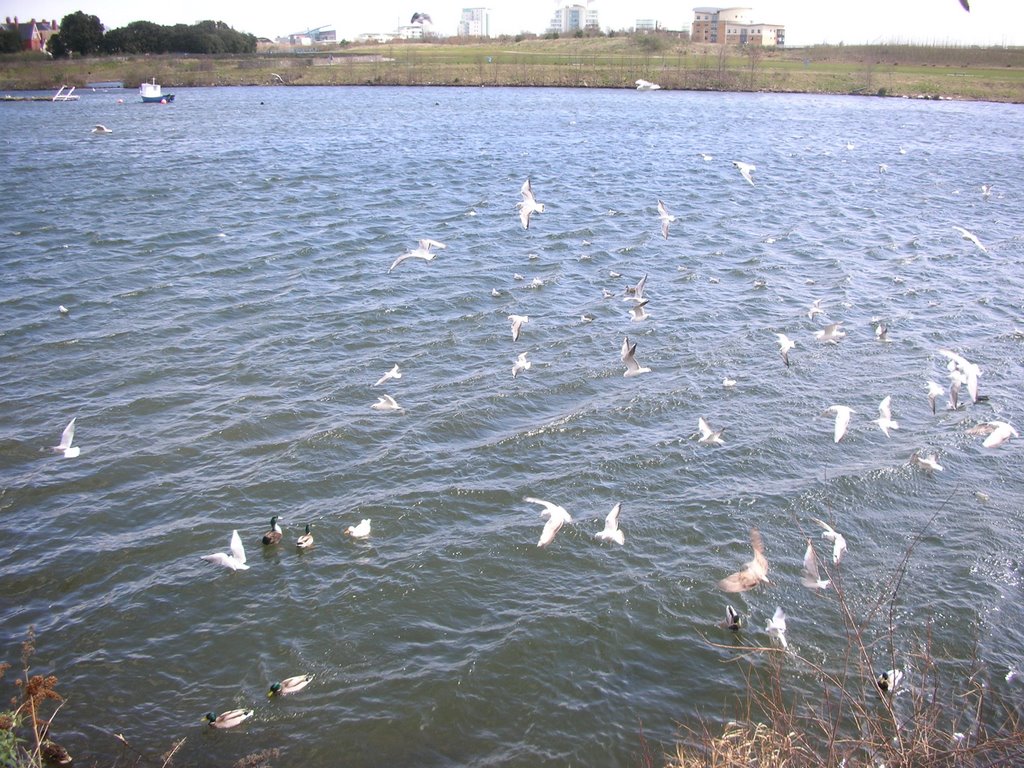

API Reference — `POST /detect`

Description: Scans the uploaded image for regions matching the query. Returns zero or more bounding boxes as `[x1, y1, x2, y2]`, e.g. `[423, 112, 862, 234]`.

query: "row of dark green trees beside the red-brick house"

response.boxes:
[47, 10, 256, 56]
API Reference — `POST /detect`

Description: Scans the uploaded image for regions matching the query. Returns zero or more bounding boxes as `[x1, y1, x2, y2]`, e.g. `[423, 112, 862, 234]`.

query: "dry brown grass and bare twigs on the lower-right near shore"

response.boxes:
[668, 505, 1024, 768]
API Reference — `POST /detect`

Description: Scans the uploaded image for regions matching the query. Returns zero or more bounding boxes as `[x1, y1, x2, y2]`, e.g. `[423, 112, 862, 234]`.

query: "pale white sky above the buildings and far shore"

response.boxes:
[8, 0, 1024, 46]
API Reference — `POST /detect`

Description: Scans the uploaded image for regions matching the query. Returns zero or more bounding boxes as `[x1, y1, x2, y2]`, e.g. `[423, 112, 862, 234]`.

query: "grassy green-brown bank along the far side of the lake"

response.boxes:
[0, 36, 1024, 103]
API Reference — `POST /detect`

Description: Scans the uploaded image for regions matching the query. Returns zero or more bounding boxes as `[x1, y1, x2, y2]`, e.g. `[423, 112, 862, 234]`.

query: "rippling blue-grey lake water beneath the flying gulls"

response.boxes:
[0, 88, 1024, 766]
